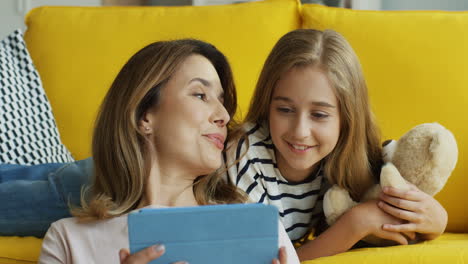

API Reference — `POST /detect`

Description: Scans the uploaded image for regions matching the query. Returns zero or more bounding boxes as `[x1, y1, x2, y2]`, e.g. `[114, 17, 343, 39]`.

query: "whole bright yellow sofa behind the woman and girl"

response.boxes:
[0, 0, 468, 264]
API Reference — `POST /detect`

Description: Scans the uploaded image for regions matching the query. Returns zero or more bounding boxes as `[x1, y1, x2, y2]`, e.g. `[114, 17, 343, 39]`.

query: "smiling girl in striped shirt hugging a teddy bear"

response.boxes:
[225, 29, 447, 260]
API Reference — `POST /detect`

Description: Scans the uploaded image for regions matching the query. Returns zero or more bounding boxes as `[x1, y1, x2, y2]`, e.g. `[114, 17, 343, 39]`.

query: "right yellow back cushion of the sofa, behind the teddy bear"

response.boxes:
[302, 4, 468, 232]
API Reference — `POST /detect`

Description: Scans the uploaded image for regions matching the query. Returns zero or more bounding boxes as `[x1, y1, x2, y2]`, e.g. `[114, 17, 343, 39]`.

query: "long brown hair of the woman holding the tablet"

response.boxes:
[72, 39, 245, 220]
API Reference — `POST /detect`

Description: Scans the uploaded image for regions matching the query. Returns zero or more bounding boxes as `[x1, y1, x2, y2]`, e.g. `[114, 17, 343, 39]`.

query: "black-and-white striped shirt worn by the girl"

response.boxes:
[225, 124, 326, 243]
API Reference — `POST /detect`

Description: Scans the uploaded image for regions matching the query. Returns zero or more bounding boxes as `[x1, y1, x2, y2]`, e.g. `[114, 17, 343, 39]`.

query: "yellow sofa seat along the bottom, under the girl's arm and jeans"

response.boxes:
[0, 233, 468, 264]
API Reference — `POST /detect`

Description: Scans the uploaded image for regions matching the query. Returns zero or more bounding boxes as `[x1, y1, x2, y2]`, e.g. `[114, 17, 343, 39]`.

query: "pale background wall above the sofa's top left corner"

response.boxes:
[0, 0, 101, 39]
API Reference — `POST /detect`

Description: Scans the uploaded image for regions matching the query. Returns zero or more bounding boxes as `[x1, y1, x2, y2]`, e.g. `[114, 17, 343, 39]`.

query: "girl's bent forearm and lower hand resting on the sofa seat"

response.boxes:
[297, 200, 408, 261]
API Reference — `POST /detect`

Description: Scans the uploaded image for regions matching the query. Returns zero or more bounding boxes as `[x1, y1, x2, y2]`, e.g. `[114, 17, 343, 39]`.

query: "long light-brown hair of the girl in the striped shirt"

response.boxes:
[235, 29, 381, 199]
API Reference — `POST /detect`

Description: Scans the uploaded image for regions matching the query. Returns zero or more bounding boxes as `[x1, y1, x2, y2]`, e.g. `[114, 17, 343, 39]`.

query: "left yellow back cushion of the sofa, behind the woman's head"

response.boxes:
[25, 0, 300, 159]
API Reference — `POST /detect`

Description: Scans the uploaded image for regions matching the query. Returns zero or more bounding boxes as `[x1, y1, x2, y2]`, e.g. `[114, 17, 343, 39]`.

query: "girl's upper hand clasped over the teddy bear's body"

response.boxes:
[379, 184, 448, 240]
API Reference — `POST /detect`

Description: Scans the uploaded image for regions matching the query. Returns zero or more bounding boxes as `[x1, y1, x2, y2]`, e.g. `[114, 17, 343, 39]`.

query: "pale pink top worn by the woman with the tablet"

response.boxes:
[39, 206, 299, 264]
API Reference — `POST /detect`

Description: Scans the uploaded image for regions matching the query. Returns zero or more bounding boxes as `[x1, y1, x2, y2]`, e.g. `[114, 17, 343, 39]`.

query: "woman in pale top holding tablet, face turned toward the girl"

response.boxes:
[39, 40, 299, 264]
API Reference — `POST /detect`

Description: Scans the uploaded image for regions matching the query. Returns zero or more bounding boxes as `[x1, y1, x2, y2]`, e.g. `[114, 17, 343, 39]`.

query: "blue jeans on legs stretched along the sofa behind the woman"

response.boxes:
[0, 158, 93, 237]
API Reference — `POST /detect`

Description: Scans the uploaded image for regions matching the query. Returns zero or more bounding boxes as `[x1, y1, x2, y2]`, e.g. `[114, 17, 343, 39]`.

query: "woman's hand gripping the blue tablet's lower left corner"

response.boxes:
[119, 245, 188, 264]
